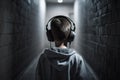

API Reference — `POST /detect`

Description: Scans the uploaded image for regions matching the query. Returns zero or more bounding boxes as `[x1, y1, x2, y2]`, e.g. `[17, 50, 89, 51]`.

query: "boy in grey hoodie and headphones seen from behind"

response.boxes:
[36, 16, 95, 80]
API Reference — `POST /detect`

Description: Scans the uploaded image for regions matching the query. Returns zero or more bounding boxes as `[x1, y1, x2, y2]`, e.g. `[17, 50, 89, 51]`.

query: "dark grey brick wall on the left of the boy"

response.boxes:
[0, 0, 42, 80]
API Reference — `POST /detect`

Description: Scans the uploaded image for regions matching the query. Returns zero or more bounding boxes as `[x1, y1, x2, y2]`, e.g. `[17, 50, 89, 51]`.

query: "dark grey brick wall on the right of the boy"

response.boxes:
[75, 0, 120, 80]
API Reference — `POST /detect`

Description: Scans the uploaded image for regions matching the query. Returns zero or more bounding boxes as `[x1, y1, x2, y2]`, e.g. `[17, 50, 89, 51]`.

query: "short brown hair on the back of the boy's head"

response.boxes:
[51, 17, 71, 42]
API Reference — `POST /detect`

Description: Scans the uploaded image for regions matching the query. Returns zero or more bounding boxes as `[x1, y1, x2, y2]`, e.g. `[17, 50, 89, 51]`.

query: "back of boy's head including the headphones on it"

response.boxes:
[46, 16, 76, 46]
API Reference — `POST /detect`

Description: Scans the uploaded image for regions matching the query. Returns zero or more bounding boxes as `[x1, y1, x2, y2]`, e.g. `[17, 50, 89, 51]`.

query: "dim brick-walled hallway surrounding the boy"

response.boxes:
[0, 0, 120, 80]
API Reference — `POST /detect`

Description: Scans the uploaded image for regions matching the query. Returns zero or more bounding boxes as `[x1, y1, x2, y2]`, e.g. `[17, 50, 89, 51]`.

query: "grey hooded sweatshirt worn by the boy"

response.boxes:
[36, 47, 95, 80]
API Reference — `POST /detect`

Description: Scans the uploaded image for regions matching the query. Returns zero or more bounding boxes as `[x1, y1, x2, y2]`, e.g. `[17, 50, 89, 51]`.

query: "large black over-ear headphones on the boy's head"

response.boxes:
[46, 15, 76, 43]
